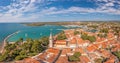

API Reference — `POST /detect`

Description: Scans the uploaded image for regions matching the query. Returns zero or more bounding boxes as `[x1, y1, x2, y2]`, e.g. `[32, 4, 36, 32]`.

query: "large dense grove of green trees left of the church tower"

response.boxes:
[0, 37, 49, 61]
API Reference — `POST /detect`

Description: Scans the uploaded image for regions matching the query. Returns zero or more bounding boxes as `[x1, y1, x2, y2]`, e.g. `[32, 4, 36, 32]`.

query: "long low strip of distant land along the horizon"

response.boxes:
[22, 21, 120, 26]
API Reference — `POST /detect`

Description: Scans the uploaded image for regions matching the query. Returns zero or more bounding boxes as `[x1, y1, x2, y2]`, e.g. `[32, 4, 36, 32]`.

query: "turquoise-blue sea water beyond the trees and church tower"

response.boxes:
[0, 23, 67, 42]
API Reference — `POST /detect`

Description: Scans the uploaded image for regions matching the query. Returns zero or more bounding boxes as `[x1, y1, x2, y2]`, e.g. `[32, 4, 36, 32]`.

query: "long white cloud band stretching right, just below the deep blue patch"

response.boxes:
[40, 6, 120, 15]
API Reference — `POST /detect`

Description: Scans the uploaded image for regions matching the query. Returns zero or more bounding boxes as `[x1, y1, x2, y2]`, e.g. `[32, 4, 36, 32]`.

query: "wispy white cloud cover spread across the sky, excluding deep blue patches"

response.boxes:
[0, 0, 120, 22]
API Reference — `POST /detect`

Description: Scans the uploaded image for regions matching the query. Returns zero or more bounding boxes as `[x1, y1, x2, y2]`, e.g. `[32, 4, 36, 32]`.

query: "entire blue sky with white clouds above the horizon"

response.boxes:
[0, 0, 120, 22]
